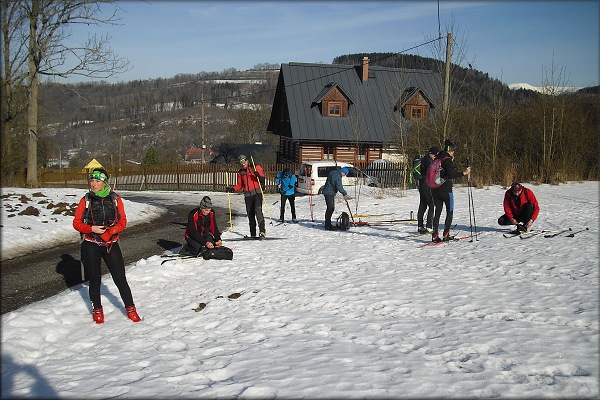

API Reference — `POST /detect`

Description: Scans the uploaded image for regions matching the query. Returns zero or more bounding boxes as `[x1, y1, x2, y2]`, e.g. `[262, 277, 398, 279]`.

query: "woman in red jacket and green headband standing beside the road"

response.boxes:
[73, 168, 141, 324]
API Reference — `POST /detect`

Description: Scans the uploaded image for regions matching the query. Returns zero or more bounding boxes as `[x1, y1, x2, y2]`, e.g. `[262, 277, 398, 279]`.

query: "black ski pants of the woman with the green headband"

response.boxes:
[81, 240, 134, 308]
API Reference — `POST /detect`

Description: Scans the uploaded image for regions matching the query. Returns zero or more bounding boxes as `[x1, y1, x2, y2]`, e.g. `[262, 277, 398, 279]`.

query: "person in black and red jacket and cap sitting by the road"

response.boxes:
[184, 196, 223, 256]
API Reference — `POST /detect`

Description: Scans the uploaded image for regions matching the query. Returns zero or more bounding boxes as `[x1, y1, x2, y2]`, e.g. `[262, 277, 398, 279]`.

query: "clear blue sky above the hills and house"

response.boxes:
[62, 0, 600, 86]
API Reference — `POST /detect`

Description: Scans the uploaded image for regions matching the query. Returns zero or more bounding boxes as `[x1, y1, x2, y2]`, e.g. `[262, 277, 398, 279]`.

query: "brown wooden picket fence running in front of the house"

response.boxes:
[40, 163, 406, 193]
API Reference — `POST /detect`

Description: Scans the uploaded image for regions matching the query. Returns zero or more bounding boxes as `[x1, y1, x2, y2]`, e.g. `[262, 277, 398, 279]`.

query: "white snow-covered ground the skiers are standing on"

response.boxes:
[1, 182, 600, 398]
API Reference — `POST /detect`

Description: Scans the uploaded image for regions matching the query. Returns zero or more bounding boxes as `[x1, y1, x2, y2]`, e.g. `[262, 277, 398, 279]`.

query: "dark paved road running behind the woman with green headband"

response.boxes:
[0, 194, 229, 314]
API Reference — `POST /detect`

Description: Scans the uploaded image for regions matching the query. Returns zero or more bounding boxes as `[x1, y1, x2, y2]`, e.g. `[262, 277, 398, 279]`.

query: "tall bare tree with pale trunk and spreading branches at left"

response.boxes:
[2, 0, 129, 187]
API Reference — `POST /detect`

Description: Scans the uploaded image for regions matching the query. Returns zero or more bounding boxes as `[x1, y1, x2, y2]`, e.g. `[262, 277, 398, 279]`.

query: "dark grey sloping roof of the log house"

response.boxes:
[268, 63, 442, 143]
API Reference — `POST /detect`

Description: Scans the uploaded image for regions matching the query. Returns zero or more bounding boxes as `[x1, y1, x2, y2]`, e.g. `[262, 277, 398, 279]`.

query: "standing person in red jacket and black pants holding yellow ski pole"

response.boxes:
[225, 155, 267, 239]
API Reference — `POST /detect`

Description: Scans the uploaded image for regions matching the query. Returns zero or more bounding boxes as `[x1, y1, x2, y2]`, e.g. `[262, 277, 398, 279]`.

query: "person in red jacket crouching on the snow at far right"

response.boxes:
[498, 182, 540, 232]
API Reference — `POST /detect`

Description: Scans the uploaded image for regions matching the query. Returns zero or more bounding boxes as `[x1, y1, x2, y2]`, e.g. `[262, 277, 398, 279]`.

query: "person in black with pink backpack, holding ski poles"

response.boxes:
[431, 141, 471, 242]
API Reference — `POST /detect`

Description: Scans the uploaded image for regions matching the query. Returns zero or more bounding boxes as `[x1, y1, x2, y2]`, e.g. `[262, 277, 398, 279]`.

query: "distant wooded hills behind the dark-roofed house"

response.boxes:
[41, 53, 598, 167]
